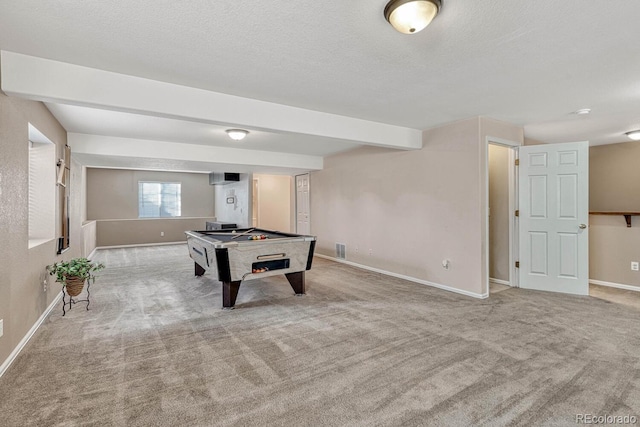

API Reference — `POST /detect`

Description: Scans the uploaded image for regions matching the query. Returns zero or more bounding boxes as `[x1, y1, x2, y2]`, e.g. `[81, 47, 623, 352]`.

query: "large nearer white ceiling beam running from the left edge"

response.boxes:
[0, 51, 422, 150]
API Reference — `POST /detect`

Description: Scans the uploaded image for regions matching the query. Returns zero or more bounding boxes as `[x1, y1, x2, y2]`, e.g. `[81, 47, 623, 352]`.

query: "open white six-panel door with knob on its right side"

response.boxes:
[518, 142, 589, 295]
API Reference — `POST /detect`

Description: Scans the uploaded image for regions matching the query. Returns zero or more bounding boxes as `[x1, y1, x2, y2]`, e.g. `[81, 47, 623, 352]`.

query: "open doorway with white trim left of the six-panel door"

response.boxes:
[487, 139, 518, 294]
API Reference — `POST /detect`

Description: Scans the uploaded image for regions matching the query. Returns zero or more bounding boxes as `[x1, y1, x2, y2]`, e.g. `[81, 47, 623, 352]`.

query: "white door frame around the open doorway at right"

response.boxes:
[483, 136, 522, 296]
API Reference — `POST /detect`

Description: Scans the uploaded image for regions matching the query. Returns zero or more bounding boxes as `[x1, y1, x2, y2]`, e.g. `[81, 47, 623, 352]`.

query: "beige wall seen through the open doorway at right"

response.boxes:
[489, 144, 510, 281]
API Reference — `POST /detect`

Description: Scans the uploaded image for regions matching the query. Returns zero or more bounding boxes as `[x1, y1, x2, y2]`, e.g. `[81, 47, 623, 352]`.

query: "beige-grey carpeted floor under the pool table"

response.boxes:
[0, 245, 640, 426]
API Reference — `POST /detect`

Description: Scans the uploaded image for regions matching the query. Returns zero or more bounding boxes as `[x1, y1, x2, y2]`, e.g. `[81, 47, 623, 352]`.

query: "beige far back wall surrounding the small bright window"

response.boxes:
[86, 168, 214, 247]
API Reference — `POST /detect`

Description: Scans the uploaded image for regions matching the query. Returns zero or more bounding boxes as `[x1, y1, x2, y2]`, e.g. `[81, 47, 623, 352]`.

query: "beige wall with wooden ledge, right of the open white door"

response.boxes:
[589, 141, 640, 287]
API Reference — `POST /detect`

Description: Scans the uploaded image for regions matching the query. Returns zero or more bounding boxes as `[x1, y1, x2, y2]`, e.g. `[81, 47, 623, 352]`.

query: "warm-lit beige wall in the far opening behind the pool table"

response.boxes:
[253, 174, 292, 232]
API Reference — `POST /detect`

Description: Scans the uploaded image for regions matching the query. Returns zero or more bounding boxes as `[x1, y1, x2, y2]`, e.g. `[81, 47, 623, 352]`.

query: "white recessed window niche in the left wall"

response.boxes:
[29, 124, 56, 248]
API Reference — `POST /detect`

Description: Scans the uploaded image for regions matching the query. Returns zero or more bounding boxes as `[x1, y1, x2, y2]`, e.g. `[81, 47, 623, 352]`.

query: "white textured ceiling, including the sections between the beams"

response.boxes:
[0, 0, 640, 172]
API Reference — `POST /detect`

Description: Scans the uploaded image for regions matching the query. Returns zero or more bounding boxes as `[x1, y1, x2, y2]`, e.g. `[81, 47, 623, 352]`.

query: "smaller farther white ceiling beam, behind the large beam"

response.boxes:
[67, 133, 323, 171]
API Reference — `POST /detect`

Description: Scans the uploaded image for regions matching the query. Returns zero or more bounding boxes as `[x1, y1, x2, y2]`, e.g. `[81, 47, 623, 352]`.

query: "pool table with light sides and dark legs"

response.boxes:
[185, 228, 316, 309]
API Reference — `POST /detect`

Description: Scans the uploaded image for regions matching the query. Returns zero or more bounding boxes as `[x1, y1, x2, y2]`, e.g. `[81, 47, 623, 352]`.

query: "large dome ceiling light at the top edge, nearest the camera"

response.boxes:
[384, 0, 442, 34]
